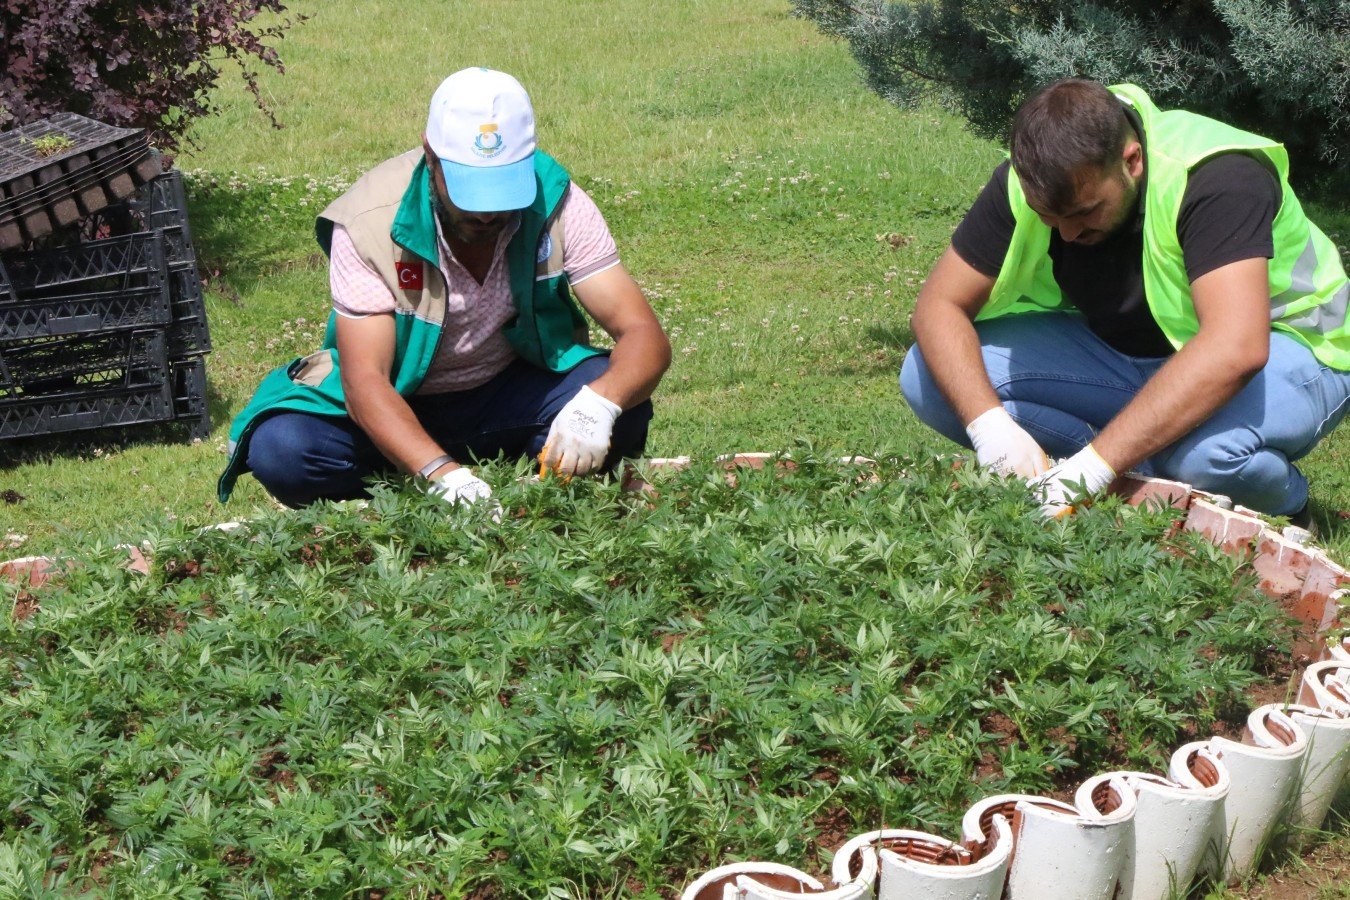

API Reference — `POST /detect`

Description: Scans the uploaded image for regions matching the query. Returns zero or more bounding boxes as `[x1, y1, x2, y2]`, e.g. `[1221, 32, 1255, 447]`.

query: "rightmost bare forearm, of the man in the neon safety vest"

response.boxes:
[1092, 332, 1260, 472]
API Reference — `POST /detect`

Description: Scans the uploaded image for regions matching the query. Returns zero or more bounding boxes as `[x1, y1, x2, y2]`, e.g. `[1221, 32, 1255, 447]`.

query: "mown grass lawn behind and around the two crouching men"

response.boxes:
[0, 0, 1350, 553]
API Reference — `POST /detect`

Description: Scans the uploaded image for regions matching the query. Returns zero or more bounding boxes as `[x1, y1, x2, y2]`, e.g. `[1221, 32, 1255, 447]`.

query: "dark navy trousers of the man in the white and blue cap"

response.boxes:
[248, 356, 652, 506]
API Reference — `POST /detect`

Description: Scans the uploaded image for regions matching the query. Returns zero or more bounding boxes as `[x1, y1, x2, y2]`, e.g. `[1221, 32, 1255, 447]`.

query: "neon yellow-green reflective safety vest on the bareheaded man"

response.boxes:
[977, 85, 1350, 371]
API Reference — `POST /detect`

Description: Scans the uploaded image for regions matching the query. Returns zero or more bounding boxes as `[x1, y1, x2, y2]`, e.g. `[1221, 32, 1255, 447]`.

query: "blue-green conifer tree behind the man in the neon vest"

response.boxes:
[792, 0, 1350, 183]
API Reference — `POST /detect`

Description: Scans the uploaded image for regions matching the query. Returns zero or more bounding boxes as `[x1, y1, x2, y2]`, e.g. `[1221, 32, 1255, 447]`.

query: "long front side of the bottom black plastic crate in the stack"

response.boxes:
[0, 379, 173, 440]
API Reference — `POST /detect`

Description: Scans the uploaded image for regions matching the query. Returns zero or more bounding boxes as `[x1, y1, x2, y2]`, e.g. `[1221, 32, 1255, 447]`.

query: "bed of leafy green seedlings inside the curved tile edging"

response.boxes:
[0, 461, 1284, 900]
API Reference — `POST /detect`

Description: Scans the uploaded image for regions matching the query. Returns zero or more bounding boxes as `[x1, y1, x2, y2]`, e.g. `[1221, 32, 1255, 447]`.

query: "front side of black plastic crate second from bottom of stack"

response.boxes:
[0, 329, 169, 405]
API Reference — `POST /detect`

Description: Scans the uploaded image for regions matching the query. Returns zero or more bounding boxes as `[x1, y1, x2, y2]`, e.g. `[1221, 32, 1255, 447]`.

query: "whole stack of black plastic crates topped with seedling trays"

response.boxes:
[0, 115, 211, 439]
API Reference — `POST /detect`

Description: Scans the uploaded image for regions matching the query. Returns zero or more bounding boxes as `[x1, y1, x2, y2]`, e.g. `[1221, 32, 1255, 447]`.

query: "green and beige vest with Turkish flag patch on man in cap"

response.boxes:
[217, 150, 603, 502]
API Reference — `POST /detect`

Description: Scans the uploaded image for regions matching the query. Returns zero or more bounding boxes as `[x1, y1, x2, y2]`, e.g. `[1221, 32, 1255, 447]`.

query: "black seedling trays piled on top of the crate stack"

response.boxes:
[0, 113, 161, 250]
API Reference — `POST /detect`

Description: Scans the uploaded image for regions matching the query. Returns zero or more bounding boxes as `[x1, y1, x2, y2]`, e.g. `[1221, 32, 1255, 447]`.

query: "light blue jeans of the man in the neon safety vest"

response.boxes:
[900, 313, 1350, 515]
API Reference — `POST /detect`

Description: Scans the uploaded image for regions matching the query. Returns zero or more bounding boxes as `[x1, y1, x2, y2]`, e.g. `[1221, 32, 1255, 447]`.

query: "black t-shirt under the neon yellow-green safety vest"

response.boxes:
[952, 135, 1281, 356]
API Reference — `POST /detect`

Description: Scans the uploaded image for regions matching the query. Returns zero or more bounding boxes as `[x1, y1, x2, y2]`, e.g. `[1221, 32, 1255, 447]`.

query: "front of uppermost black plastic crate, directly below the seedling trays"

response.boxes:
[0, 232, 171, 344]
